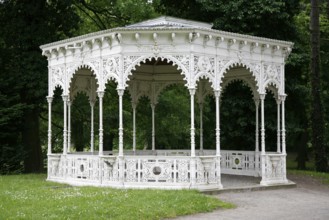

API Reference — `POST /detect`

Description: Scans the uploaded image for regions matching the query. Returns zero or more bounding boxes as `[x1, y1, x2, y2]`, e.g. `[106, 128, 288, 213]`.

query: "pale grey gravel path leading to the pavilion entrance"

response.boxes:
[176, 175, 329, 220]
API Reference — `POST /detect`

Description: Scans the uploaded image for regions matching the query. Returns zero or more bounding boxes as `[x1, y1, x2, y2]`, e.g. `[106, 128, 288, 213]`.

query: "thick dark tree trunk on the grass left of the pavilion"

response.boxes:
[22, 108, 43, 173]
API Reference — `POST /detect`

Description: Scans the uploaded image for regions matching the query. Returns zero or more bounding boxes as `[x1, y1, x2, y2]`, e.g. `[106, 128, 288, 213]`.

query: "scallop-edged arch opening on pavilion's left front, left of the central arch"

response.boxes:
[67, 64, 100, 152]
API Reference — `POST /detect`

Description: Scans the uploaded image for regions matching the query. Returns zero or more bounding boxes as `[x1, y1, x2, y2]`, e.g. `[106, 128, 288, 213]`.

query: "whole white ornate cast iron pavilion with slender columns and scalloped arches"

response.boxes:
[41, 17, 293, 190]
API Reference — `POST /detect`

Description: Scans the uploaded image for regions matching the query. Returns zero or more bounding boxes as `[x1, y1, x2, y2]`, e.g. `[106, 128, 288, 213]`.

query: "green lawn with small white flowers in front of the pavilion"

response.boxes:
[0, 174, 234, 219]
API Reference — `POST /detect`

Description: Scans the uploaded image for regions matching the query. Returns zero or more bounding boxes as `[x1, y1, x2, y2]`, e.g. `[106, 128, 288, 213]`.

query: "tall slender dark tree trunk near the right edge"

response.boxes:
[310, 0, 328, 172]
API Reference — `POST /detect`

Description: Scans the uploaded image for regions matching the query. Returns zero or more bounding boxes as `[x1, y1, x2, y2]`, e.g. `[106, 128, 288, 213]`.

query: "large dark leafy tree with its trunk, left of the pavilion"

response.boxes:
[0, 0, 78, 172]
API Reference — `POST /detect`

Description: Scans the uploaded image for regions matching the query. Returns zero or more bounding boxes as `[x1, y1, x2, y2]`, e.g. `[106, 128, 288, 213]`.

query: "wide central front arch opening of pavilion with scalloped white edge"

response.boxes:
[127, 56, 189, 150]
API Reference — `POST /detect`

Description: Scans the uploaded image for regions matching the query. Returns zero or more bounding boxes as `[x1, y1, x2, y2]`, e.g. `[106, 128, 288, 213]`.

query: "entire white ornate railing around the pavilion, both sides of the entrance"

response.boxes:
[48, 150, 287, 188]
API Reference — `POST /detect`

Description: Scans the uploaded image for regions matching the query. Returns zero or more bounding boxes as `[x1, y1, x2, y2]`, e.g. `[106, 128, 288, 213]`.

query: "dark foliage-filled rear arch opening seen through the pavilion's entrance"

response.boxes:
[221, 80, 256, 151]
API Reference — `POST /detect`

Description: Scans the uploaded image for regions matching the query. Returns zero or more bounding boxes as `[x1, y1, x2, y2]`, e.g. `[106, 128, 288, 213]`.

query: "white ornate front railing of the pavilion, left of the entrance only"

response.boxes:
[48, 154, 220, 188]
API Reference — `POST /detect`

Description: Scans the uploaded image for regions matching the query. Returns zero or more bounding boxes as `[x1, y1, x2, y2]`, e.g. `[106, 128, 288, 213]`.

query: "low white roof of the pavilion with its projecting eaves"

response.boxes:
[40, 16, 293, 51]
